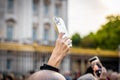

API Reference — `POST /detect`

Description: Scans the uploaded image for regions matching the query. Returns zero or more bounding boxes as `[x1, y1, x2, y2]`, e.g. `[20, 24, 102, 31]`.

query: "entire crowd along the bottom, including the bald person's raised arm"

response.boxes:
[0, 33, 120, 80]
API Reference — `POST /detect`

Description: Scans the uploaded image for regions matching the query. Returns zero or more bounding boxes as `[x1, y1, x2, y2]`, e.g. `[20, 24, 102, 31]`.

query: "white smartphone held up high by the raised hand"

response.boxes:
[53, 17, 70, 38]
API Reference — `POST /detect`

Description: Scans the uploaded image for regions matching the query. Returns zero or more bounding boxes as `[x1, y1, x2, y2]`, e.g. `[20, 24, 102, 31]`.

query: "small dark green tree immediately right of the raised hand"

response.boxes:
[71, 33, 81, 47]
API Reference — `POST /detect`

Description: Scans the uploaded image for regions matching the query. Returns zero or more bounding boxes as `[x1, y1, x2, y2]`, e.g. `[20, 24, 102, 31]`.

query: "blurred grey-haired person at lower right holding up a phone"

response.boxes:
[78, 56, 107, 80]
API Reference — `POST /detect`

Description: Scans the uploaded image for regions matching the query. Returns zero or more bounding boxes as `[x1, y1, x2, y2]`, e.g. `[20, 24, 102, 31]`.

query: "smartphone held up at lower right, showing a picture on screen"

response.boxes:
[89, 56, 102, 77]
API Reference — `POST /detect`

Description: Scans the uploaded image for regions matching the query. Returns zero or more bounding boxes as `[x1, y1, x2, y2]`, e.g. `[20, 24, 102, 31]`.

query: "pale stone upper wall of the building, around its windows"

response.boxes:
[0, 0, 67, 45]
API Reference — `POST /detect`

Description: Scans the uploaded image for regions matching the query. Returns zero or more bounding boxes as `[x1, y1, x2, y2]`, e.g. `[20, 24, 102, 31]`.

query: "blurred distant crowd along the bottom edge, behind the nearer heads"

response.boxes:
[0, 70, 120, 80]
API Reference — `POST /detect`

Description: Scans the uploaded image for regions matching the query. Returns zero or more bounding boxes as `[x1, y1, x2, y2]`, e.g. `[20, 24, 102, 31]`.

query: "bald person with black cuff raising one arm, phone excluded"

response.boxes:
[28, 33, 71, 80]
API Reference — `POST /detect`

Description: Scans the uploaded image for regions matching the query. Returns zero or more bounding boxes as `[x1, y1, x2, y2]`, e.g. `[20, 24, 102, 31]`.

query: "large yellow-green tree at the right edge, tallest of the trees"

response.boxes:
[95, 15, 120, 50]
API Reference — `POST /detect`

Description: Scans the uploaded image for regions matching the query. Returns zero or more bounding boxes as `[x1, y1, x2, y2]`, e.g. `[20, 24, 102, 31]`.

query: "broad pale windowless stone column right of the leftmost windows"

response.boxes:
[22, 0, 32, 39]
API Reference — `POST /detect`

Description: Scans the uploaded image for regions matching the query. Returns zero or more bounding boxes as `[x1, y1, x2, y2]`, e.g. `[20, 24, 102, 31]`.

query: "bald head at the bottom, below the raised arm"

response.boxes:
[28, 70, 65, 80]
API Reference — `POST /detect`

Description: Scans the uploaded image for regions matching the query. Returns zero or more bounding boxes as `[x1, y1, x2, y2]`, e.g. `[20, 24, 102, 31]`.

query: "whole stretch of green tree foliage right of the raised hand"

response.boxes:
[72, 15, 120, 50]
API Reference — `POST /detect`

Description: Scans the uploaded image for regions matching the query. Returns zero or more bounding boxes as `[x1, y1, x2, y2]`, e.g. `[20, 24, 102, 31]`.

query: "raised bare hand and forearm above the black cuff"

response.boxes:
[47, 33, 72, 68]
